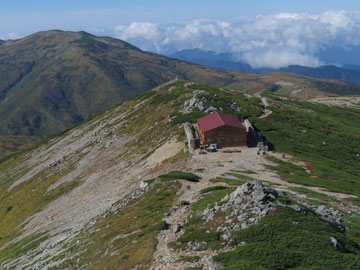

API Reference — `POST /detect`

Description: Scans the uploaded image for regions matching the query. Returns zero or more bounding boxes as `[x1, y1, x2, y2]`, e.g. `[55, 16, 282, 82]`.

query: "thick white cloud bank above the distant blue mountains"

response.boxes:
[113, 11, 360, 68]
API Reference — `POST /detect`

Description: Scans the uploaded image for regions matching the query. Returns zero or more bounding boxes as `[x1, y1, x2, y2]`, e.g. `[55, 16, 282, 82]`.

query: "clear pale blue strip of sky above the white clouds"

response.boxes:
[0, 0, 360, 31]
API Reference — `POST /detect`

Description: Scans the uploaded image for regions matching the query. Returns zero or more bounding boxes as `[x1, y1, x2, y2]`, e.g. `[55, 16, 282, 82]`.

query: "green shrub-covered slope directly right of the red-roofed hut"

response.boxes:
[251, 94, 360, 199]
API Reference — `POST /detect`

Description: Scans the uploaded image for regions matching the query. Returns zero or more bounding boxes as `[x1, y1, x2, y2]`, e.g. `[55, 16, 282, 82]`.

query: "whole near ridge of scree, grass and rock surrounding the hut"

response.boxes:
[0, 81, 360, 269]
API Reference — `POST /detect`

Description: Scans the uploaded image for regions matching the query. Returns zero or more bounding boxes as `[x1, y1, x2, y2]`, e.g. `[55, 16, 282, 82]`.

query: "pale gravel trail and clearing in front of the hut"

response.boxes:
[151, 147, 354, 270]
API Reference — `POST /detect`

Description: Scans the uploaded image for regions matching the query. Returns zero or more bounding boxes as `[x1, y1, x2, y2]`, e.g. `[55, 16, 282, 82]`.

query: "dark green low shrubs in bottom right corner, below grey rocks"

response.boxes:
[214, 207, 360, 270]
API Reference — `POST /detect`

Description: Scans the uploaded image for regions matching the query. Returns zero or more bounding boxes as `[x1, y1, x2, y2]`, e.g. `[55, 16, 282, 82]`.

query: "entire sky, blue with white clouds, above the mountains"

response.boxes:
[0, 0, 360, 67]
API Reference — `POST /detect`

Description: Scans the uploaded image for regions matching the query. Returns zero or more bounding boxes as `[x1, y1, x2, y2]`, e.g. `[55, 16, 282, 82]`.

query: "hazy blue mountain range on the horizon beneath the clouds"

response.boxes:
[169, 49, 360, 83]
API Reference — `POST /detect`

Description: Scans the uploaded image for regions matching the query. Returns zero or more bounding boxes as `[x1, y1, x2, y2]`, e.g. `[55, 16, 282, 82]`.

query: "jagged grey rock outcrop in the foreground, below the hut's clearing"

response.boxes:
[199, 181, 345, 245]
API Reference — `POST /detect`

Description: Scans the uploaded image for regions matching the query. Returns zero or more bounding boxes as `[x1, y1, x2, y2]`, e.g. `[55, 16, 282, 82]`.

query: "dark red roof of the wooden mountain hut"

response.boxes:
[198, 112, 246, 132]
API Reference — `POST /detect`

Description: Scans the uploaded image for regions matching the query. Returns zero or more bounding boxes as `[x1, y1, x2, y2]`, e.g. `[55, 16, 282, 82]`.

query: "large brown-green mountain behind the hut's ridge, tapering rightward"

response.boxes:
[0, 30, 360, 136]
